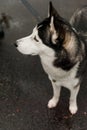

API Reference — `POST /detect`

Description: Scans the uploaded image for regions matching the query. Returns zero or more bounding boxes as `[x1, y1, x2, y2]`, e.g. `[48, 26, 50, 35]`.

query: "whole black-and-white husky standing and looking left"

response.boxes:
[15, 2, 87, 114]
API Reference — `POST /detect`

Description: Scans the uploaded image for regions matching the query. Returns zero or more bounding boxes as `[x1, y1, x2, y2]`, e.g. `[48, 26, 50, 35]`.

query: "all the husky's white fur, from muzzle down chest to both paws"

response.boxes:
[17, 27, 79, 114]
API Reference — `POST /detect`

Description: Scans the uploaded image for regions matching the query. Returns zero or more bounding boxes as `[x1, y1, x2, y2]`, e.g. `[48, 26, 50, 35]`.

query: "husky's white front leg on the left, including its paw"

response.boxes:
[48, 78, 61, 108]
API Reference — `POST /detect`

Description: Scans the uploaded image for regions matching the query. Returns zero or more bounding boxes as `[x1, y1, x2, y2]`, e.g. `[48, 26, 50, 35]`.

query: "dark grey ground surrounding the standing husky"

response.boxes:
[0, 0, 87, 130]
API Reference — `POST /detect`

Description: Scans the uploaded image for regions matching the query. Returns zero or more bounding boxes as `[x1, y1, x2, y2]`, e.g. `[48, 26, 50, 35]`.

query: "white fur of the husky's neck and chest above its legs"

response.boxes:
[40, 56, 79, 88]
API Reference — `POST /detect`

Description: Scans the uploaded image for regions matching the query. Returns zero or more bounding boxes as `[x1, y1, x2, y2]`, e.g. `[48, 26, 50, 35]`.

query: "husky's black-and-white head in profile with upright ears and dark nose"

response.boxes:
[15, 2, 70, 55]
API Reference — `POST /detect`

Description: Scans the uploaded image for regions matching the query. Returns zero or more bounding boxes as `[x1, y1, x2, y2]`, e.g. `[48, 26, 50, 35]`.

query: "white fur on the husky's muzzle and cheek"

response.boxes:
[17, 27, 54, 55]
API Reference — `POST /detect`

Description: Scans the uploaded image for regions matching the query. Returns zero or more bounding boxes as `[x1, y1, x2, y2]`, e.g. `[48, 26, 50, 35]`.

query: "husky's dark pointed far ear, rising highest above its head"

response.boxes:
[48, 1, 60, 17]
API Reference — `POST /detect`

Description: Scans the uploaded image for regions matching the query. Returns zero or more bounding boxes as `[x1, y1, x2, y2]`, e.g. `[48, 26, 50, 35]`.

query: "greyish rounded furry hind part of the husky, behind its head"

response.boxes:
[70, 5, 87, 43]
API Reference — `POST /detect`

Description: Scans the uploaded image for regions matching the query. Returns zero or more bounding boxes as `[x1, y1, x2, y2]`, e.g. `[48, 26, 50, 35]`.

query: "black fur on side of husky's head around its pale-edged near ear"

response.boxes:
[37, 17, 65, 51]
